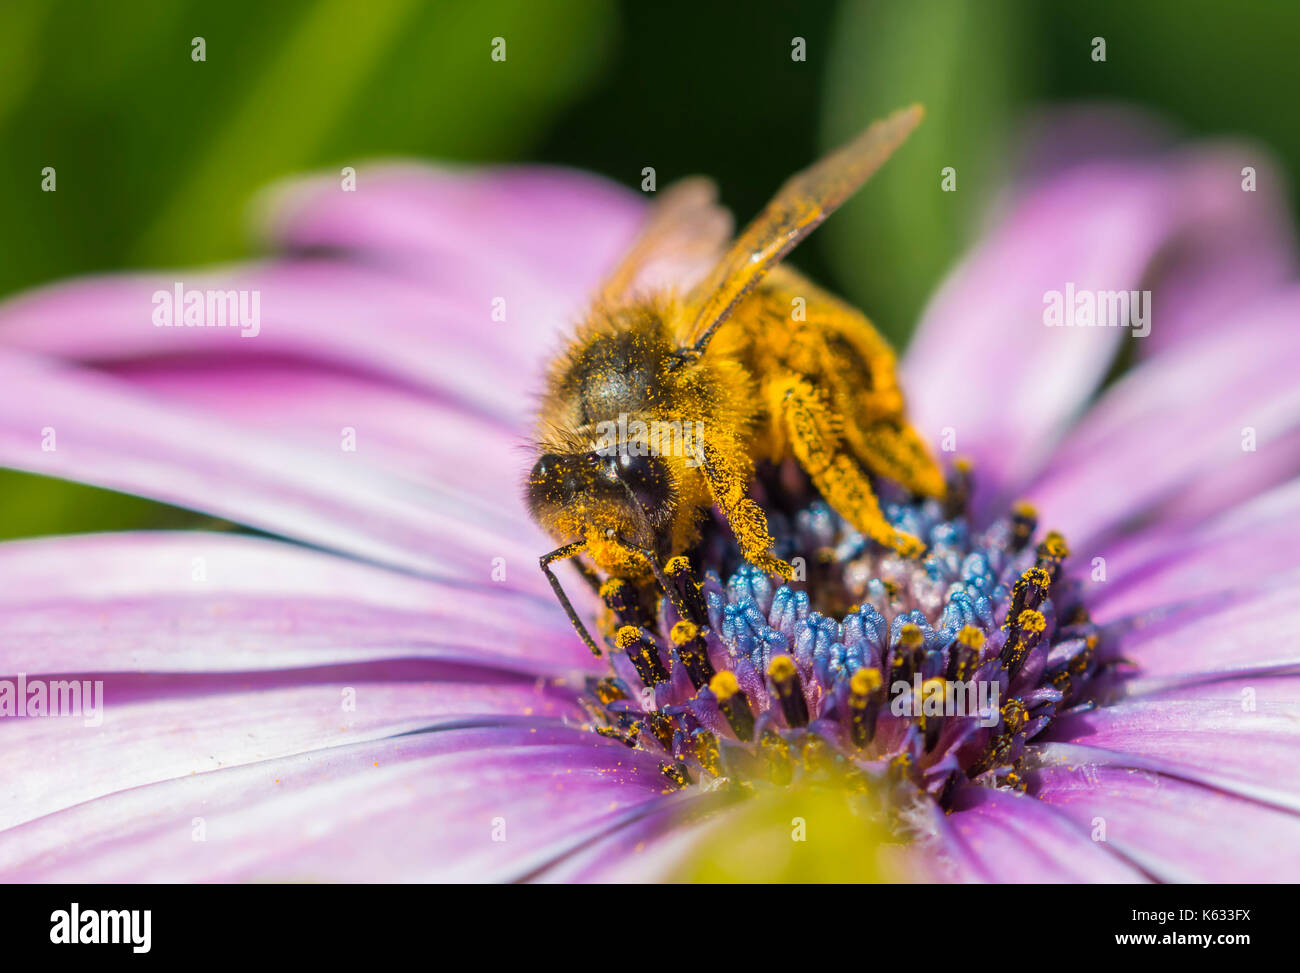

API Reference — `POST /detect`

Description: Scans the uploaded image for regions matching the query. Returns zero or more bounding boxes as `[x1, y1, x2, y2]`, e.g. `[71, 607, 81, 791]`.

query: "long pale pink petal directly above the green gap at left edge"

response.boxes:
[0, 354, 566, 594]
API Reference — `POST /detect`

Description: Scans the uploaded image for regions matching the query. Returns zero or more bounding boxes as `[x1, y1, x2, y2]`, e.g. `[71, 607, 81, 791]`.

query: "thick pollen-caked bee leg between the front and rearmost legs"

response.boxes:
[770, 377, 926, 557]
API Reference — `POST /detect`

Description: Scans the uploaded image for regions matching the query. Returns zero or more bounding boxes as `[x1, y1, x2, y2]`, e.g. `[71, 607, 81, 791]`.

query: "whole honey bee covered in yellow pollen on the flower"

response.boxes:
[525, 105, 945, 656]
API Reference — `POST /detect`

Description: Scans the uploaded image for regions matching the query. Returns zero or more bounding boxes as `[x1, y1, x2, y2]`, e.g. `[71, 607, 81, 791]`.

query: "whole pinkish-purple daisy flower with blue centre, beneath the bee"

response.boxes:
[0, 114, 1300, 882]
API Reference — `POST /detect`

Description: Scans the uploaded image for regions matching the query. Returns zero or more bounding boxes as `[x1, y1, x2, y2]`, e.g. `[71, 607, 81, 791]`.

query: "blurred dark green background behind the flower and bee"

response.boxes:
[0, 0, 1300, 536]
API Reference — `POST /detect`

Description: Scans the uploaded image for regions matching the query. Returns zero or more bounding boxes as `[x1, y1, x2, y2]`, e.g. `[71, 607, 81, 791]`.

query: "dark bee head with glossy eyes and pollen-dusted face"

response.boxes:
[527, 444, 676, 546]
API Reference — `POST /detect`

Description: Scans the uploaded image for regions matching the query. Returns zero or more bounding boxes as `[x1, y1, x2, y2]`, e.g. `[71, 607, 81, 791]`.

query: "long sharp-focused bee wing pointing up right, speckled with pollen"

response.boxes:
[683, 105, 924, 351]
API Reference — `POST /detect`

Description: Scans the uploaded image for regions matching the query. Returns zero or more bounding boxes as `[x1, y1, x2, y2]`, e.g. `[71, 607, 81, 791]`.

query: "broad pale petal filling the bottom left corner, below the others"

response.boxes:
[0, 719, 664, 882]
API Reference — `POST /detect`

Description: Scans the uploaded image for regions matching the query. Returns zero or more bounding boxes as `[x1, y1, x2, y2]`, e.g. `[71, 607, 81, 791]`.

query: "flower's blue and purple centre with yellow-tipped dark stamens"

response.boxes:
[585, 468, 1100, 805]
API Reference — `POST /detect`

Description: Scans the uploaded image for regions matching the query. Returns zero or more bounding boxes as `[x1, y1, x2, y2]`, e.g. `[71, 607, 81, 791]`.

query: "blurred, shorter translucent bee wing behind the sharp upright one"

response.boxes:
[598, 176, 732, 303]
